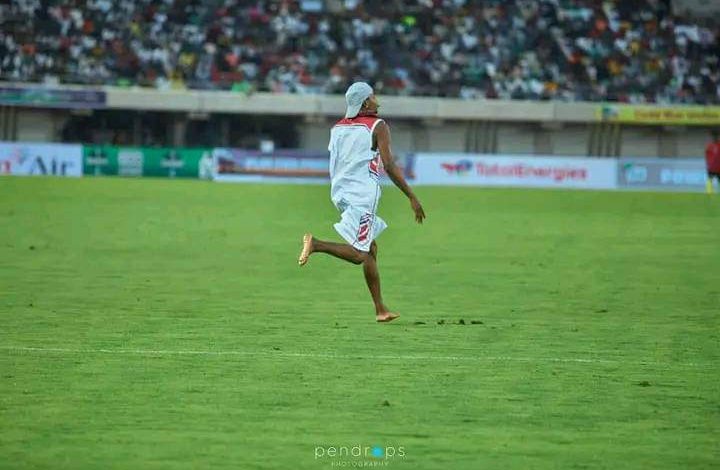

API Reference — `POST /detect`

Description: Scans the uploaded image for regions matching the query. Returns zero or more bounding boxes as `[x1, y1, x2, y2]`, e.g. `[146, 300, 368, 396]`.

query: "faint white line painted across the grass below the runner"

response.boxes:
[0, 346, 715, 368]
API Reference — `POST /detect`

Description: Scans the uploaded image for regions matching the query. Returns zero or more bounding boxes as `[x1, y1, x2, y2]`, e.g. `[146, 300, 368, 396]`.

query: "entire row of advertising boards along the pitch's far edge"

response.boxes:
[0, 142, 707, 192]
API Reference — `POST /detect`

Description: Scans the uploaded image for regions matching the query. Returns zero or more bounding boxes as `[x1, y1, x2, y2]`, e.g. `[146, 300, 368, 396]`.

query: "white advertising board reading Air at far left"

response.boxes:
[0, 142, 83, 177]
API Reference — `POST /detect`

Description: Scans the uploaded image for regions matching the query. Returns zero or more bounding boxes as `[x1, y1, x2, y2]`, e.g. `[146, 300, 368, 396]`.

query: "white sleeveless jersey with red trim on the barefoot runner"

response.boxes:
[328, 116, 382, 213]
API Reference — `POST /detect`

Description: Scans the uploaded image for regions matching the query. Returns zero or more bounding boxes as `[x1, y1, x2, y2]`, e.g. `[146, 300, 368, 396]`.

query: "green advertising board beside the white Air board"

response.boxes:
[83, 145, 211, 178]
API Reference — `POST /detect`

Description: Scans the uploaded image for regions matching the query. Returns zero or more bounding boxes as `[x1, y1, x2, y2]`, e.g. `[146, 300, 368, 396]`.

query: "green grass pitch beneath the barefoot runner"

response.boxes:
[0, 178, 720, 469]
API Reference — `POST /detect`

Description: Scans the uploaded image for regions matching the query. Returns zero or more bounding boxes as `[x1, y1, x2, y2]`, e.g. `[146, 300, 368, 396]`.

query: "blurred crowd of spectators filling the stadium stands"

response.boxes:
[0, 0, 720, 104]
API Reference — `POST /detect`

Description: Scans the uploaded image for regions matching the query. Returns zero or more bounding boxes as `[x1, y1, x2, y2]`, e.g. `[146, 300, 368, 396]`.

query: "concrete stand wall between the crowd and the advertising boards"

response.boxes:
[0, 83, 717, 157]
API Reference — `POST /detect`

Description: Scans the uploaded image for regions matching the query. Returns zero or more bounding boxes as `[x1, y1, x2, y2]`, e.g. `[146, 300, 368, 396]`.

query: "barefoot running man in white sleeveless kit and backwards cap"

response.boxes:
[298, 82, 425, 322]
